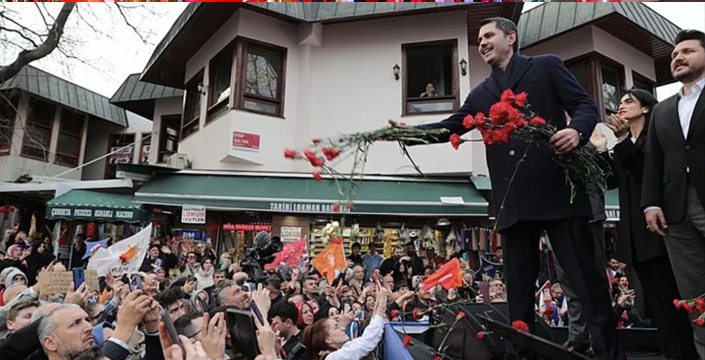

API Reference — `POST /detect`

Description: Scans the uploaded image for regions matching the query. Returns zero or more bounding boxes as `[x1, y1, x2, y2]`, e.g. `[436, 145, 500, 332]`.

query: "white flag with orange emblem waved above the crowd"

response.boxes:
[87, 224, 152, 276]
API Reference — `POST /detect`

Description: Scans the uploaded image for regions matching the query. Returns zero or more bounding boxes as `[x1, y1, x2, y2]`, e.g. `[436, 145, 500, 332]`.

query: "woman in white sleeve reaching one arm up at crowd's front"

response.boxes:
[303, 280, 389, 360]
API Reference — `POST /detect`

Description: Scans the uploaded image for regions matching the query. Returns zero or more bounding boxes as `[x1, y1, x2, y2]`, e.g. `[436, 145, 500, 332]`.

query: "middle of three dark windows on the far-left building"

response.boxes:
[22, 100, 56, 161]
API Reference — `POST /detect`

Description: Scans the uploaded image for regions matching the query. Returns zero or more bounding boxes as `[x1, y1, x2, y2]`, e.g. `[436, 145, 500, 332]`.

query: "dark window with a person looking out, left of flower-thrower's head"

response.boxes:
[402, 40, 458, 115]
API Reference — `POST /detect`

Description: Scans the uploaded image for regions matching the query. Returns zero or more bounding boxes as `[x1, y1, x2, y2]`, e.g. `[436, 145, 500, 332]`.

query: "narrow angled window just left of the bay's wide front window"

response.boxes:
[206, 46, 233, 123]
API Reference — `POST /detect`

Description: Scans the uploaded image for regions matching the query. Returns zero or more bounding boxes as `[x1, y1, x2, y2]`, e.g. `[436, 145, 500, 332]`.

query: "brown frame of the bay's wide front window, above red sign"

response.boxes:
[232, 37, 288, 118]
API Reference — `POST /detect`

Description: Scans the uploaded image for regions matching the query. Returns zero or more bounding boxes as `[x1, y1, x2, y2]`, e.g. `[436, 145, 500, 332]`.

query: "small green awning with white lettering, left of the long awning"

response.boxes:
[46, 190, 150, 224]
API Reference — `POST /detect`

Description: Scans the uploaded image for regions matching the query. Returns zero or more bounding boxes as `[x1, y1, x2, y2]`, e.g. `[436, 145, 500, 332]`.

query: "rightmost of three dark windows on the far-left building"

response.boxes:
[54, 109, 86, 167]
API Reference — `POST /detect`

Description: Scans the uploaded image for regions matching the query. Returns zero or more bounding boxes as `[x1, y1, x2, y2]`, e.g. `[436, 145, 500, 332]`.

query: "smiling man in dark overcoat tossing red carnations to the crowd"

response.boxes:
[421, 17, 624, 359]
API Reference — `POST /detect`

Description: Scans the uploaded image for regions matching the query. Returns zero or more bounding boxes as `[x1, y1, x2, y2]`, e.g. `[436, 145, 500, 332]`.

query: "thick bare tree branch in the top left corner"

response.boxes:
[0, 3, 76, 83]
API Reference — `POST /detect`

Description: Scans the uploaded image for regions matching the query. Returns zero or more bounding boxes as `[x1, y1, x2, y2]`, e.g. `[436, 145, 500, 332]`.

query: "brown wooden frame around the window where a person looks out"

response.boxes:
[400, 38, 460, 116]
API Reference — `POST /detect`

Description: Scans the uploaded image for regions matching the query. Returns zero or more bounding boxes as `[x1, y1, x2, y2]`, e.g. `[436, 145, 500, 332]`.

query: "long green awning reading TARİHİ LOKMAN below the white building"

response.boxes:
[135, 174, 487, 216]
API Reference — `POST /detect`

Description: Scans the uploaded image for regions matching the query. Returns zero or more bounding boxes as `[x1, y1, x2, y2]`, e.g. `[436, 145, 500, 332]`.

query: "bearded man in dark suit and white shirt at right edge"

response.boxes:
[641, 30, 705, 358]
